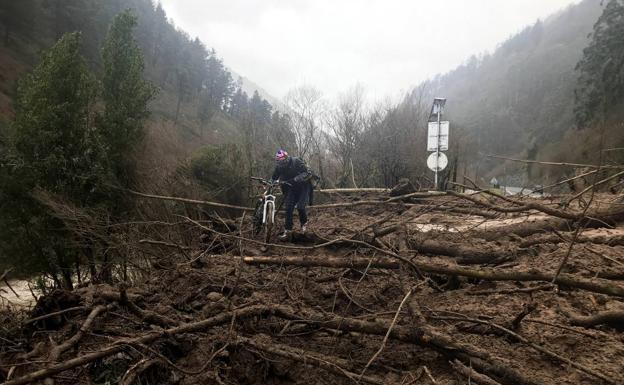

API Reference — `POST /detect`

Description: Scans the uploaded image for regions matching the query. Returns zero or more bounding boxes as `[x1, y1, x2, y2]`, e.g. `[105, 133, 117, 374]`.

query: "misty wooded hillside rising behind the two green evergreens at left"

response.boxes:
[0, 0, 276, 162]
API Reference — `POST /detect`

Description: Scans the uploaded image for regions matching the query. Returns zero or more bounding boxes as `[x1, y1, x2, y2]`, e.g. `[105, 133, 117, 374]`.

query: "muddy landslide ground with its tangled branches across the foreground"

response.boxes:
[0, 194, 624, 385]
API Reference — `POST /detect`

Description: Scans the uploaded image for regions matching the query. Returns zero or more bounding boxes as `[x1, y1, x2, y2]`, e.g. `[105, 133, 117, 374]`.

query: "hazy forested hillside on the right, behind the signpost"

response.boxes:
[424, 0, 624, 184]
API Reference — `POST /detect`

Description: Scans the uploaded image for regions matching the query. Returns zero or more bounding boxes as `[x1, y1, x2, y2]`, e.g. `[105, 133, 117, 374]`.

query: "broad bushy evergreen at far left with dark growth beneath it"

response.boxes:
[0, 33, 104, 288]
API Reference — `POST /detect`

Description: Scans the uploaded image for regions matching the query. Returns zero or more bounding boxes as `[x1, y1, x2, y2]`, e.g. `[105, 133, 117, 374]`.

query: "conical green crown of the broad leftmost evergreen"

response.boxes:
[11, 33, 100, 200]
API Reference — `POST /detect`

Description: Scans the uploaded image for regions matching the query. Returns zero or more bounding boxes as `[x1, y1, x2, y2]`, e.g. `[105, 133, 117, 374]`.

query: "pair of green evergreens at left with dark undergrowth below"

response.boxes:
[0, 12, 160, 288]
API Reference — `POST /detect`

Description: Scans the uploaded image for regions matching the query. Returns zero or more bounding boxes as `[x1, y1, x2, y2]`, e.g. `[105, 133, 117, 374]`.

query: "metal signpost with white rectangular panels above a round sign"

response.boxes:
[427, 98, 450, 191]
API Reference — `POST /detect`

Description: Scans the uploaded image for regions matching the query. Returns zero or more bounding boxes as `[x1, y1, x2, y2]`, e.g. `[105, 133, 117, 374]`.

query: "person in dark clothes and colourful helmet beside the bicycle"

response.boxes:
[271, 149, 313, 239]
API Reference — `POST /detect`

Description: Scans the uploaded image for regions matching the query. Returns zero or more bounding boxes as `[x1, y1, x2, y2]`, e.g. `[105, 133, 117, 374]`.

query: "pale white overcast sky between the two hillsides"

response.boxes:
[161, 0, 578, 99]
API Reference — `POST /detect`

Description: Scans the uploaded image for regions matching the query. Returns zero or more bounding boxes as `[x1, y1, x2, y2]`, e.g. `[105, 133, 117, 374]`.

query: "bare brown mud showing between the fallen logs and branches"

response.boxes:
[0, 194, 624, 385]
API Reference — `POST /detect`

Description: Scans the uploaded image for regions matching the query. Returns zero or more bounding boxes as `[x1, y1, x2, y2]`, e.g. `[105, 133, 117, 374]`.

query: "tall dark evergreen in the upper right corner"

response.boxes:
[575, 0, 624, 127]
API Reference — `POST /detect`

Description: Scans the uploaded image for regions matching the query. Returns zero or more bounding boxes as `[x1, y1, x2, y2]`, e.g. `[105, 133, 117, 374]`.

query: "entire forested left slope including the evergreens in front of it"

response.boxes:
[0, 0, 300, 280]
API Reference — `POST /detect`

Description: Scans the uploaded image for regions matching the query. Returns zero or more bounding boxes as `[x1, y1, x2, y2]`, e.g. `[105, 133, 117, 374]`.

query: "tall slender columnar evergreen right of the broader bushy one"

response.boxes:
[100, 10, 156, 185]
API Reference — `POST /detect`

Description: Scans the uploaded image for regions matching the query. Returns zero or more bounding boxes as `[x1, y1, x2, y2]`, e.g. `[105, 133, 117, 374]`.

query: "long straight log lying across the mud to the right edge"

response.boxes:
[243, 256, 624, 297]
